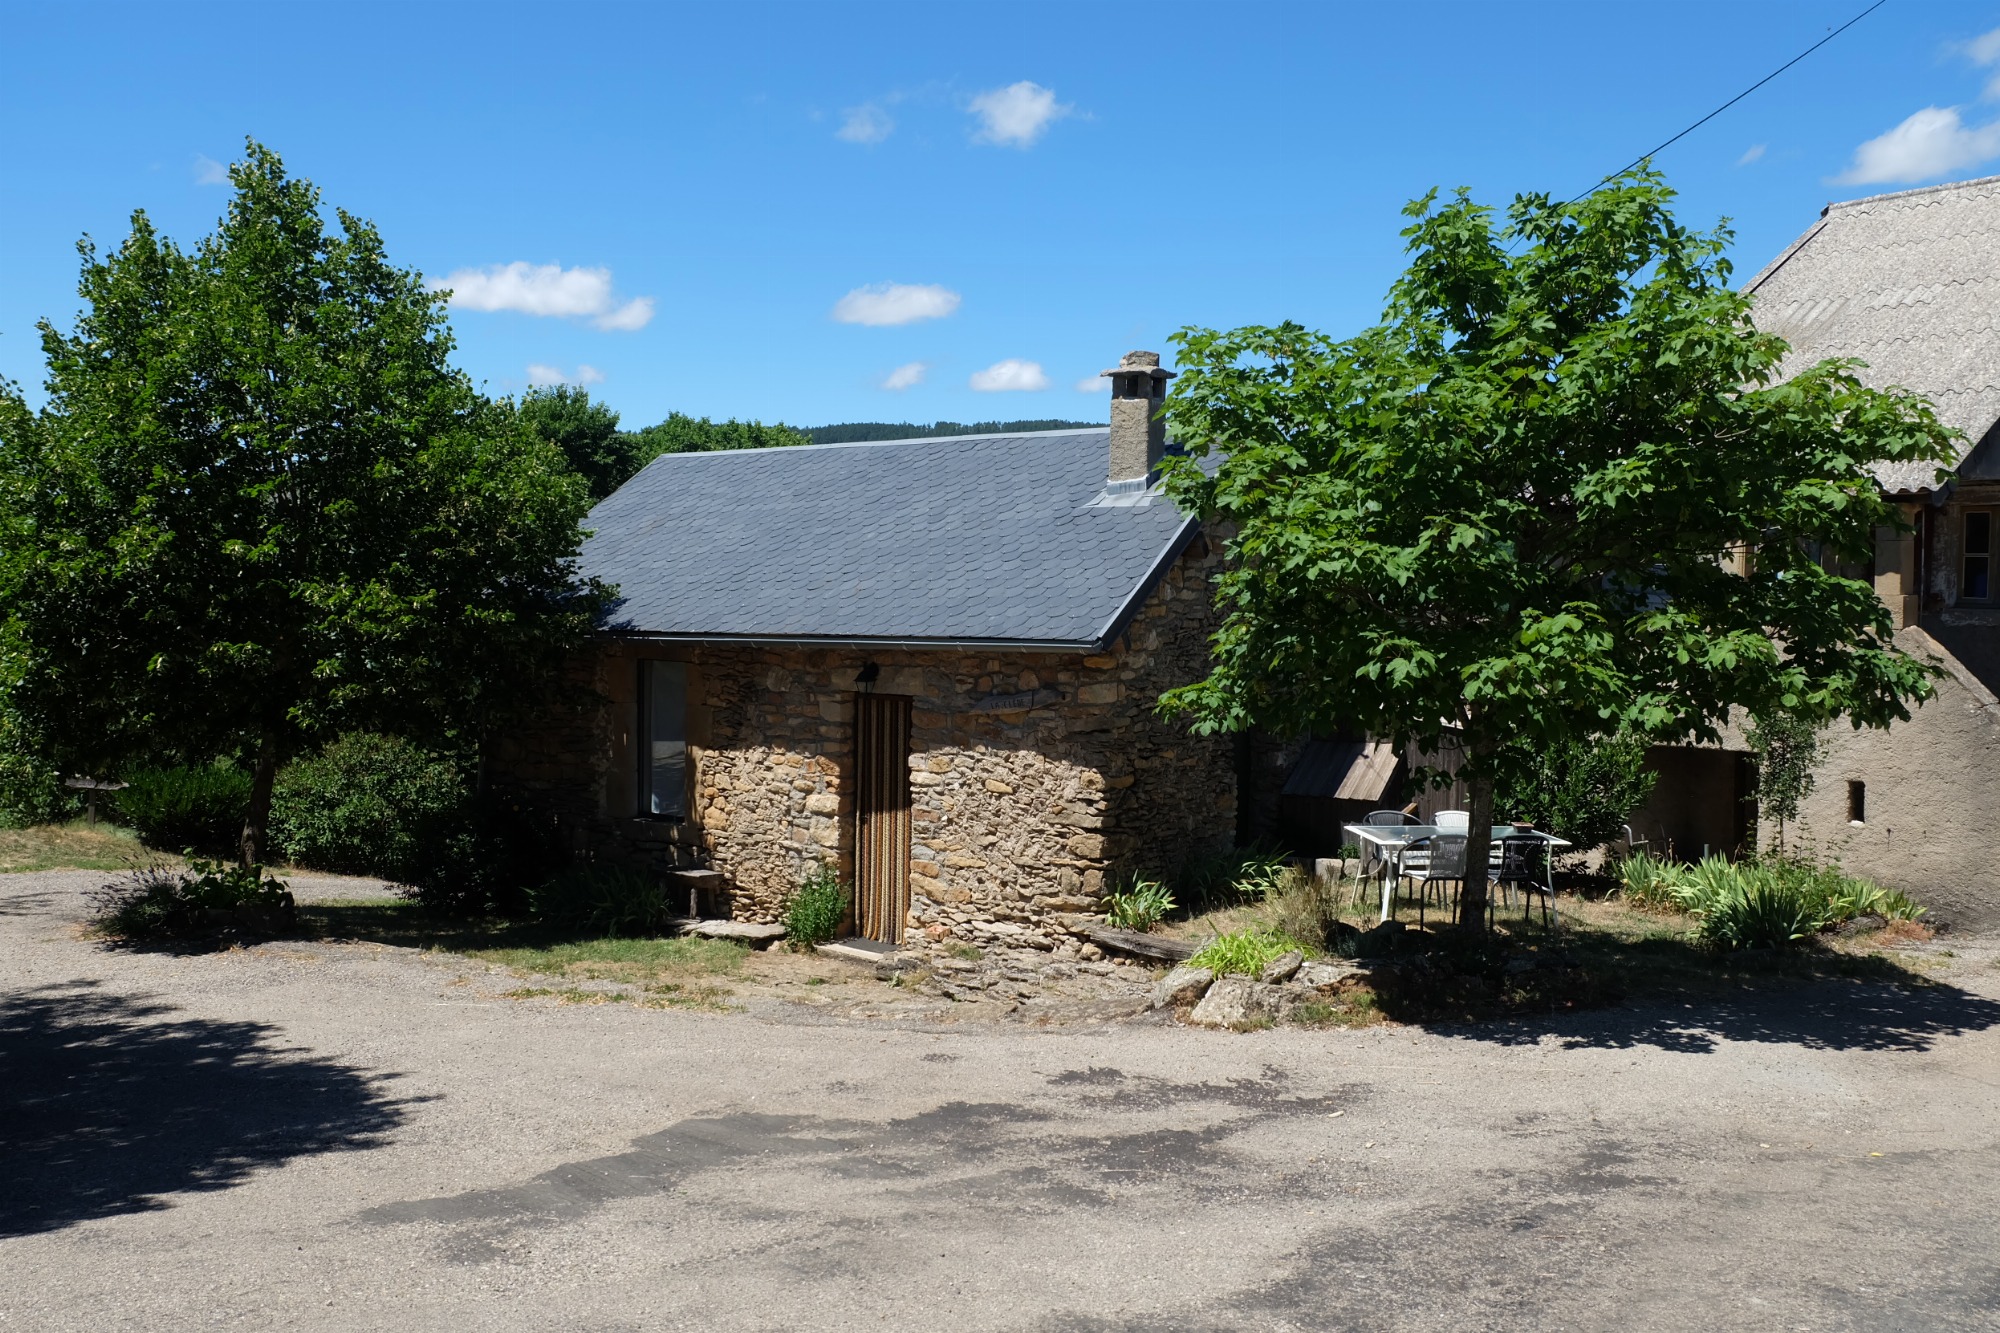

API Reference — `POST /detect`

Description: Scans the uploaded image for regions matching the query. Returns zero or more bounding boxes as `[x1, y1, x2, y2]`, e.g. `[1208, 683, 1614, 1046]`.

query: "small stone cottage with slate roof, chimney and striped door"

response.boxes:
[498, 352, 1238, 947]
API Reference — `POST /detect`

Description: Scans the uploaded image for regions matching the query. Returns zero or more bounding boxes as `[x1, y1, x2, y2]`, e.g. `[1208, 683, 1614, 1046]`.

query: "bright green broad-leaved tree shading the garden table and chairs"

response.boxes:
[1162, 168, 1950, 929]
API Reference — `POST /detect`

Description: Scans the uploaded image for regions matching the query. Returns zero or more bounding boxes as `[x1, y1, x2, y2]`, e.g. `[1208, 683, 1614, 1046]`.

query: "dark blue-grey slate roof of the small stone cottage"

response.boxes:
[582, 428, 1196, 650]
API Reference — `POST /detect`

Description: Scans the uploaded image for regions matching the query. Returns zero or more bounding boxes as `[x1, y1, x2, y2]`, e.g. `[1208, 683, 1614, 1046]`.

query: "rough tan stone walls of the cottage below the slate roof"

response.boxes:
[496, 540, 1236, 947]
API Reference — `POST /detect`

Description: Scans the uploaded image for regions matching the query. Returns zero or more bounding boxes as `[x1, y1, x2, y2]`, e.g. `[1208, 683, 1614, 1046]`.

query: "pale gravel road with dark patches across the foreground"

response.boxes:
[0, 873, 2000, 1331]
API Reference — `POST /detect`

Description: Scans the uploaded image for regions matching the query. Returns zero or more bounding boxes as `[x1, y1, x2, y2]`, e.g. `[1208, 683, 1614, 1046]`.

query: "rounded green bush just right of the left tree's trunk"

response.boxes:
[270, 733, 468, 885]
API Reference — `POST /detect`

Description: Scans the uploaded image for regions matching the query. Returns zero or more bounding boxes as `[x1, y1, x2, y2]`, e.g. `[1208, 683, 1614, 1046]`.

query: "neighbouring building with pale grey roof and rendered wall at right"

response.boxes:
[1640, 176, 2000, 919]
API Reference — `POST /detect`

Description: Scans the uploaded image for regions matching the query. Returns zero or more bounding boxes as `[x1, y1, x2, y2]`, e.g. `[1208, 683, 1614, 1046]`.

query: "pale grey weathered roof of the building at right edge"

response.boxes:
[1744, 176, 2000, 492]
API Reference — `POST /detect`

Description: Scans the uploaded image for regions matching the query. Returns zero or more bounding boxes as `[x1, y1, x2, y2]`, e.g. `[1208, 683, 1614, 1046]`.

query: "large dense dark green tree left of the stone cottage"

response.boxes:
[0, 142, 604, 863]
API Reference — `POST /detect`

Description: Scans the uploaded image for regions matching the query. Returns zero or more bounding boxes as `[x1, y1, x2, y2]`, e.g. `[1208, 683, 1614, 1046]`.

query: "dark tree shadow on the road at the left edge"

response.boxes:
[0, 983, 410, 1237]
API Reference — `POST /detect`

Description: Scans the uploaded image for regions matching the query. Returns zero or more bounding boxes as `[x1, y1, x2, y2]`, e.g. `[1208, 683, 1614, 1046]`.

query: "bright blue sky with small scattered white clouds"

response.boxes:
[0, 0, 2000, 426]
